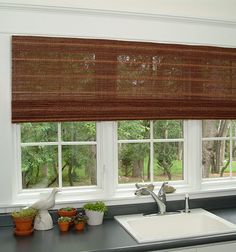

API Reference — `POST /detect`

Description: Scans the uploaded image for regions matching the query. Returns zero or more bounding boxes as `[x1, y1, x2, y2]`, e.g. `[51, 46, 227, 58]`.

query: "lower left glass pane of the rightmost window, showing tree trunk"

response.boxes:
[202, 140, 230, 178]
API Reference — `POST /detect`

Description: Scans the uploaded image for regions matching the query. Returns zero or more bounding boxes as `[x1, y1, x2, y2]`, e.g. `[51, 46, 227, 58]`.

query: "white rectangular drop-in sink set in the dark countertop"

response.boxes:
[115, 208, 236, 243]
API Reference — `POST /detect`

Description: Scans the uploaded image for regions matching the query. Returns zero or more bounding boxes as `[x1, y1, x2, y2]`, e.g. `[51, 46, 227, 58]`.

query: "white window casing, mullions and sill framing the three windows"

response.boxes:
[12, 120, 235, 209]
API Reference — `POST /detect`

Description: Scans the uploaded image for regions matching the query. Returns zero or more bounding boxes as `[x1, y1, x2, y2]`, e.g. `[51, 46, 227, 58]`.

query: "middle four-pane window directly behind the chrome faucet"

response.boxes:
[118, 120, 184, 184]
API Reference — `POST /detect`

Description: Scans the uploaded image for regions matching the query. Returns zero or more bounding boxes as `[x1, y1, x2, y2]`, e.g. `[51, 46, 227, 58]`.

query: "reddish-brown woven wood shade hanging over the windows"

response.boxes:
[12, 36, 236, 123]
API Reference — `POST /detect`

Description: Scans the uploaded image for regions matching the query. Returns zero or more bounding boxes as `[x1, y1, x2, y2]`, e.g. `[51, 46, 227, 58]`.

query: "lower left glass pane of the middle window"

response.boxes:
[119, 143, 150, 184]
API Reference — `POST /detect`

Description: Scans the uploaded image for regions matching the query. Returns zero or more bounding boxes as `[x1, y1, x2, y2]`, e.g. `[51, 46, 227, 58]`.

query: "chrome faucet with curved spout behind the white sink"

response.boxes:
[135, 182, 168, 214]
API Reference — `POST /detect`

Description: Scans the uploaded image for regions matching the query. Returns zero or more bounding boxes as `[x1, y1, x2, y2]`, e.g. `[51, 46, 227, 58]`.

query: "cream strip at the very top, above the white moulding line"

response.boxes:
[0, 0, 236, 21]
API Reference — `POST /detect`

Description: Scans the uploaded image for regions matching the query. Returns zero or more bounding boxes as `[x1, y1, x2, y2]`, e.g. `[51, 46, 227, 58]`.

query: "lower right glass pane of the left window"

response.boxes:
[62, 145, 97, 186]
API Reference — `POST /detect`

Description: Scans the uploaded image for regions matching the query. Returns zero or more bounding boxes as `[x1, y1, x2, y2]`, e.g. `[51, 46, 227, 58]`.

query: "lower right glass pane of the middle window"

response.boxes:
[154, 142, 184, 181]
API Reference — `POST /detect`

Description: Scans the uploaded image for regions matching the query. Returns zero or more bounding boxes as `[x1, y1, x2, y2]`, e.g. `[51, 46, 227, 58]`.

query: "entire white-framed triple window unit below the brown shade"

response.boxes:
[14, 120, 236, 206]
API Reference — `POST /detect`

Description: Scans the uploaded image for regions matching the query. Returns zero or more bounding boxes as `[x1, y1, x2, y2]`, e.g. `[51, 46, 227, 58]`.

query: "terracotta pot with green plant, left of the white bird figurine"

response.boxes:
[11, 207, 37, 235]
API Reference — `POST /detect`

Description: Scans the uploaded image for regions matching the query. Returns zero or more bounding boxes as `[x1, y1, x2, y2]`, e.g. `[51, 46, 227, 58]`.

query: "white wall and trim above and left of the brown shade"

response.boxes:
[0, 0, 236, 206]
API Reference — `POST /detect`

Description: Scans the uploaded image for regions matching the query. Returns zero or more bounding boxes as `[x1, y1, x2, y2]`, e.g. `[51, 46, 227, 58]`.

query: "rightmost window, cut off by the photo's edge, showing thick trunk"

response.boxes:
[202, 120, 236, 179]
